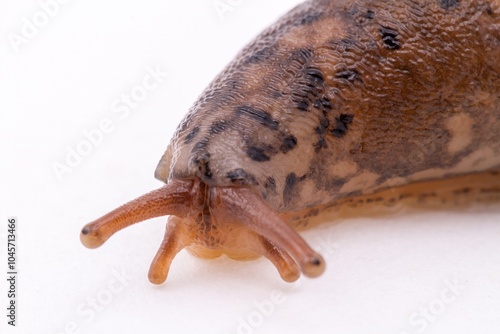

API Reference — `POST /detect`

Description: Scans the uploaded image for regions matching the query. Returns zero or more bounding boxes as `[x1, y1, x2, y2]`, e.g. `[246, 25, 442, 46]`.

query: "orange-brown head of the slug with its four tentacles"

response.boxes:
[80, 180, 325, 284]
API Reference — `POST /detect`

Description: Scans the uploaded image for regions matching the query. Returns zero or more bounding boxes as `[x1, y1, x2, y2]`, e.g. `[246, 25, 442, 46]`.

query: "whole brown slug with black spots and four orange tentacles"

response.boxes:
[80, 0, 500, 284]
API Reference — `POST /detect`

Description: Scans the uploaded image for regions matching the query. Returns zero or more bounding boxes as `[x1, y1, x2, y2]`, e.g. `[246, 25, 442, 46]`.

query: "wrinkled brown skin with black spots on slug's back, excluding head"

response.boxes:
[156, 0, 500, 211]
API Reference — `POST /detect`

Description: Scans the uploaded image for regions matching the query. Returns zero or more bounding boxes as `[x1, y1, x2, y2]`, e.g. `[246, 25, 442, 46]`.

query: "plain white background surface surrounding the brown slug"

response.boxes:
[0, 0, 500, 334]
